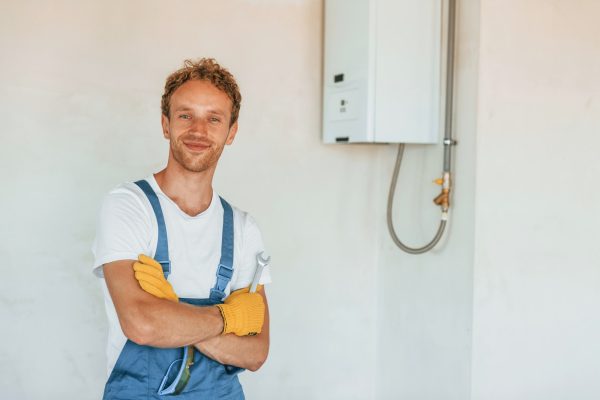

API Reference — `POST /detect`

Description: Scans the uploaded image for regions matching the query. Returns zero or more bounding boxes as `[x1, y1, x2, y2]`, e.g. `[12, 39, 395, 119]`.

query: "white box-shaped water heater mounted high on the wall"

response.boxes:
[323, 0, 445, 143]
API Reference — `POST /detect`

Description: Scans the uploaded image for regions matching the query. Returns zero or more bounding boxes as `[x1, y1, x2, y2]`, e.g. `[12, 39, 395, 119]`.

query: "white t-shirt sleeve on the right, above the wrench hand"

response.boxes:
[231, 215, 271, 291]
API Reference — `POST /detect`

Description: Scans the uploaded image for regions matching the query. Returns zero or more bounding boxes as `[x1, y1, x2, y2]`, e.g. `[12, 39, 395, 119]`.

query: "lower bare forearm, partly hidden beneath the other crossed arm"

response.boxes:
[195, 333, 269, 371]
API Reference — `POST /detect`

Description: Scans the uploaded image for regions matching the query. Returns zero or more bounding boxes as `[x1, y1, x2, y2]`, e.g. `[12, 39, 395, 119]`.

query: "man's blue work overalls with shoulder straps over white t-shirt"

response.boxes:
[103, 180, 244, 400]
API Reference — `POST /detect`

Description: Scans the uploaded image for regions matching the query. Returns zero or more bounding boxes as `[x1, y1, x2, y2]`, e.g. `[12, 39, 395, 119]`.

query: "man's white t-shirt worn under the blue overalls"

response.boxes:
[92, 175, 271, 375]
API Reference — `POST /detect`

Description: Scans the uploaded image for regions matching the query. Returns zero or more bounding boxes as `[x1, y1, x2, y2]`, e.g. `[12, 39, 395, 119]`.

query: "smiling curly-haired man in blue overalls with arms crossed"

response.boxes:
[93, 59, 271, 399]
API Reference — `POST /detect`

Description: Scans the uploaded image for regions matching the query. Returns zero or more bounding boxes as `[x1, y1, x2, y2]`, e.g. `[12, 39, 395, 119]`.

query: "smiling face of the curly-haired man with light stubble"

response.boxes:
[161, 80, 237, 172]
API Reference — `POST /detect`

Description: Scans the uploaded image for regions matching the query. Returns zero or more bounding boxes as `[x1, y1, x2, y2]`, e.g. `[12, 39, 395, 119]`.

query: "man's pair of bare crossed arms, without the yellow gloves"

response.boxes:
[104, 260, 269, 371]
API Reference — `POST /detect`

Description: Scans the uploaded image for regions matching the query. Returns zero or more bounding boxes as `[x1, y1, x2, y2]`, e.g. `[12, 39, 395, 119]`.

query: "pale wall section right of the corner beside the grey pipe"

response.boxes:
[472, 0, 600, 400]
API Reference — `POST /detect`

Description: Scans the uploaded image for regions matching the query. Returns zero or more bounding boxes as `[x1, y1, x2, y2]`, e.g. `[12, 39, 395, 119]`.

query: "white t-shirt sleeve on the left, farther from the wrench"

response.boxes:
[92, 189, 152, 277]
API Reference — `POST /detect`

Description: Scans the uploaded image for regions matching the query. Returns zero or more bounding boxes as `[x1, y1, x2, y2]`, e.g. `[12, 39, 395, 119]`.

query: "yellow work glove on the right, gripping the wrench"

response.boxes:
[217, 285, 265, 336]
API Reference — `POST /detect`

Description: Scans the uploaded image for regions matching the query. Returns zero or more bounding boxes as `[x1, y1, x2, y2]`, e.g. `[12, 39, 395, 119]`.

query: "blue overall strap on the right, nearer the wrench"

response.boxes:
[210, 197, 233, 303]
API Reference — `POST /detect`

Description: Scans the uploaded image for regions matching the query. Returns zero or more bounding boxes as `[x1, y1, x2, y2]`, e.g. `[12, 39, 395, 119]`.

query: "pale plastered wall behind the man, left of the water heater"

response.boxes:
[0, 0, 380, 399]
